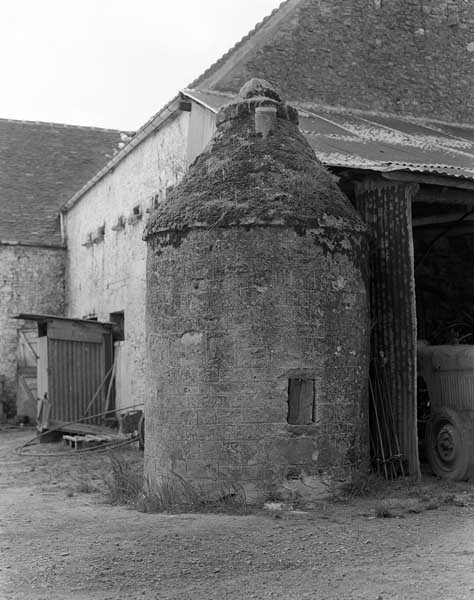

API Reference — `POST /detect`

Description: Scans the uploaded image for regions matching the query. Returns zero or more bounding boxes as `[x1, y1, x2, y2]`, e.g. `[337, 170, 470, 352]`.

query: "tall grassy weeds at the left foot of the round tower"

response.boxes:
[104, 456, 248, 514]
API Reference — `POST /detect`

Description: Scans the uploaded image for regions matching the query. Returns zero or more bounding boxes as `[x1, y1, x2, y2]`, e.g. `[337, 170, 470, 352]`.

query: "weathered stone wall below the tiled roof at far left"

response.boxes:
[0, 245, 65, 413]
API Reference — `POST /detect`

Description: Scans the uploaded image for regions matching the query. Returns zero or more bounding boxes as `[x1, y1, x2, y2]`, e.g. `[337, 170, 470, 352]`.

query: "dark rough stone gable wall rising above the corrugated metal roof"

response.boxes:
[207, 0, 474, 122]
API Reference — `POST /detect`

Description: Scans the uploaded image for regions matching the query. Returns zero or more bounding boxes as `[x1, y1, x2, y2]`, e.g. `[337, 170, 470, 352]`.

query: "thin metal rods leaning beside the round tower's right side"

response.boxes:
[369, 360, 405, 479]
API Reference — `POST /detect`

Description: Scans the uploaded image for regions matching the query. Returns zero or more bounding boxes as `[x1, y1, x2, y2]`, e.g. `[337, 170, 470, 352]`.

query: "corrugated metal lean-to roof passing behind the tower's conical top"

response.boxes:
[184, 90, 474, 179]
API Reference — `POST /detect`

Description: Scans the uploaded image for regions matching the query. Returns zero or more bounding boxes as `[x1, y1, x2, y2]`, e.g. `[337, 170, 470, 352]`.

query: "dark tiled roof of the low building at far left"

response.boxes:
[0, 119, 128, 245]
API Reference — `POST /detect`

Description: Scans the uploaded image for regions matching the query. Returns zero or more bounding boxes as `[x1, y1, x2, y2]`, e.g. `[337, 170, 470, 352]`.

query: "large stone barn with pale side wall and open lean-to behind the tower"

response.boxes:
[5, 0, 474, 482]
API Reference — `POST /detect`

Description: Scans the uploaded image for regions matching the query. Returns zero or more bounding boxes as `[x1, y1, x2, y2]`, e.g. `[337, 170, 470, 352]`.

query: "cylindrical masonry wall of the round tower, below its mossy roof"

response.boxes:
[145, 227, 369, 496]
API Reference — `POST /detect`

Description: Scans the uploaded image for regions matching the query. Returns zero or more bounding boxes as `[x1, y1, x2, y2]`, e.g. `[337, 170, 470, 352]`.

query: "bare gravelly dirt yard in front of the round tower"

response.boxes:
[0, 430, 474, 600]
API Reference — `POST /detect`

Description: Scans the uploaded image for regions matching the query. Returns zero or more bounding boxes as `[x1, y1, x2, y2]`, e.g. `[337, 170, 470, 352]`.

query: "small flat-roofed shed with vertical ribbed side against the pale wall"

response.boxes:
[17, 313, 114, 428]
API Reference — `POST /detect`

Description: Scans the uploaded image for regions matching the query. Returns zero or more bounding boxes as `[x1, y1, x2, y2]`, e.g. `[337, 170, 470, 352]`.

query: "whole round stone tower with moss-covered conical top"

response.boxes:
[145, 80, 369, 497]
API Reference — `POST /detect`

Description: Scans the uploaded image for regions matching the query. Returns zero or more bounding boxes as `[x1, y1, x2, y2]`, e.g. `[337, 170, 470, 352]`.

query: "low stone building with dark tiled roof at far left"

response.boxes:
[0, 119, 129, 418]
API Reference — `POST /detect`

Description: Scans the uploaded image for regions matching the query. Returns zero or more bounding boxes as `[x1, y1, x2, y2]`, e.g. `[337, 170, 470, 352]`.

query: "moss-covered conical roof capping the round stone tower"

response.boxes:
[145, 80, 364, 239]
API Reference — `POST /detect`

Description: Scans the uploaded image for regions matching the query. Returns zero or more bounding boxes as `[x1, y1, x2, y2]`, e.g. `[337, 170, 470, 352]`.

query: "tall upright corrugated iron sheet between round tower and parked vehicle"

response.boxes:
[357, 181, 419, 474]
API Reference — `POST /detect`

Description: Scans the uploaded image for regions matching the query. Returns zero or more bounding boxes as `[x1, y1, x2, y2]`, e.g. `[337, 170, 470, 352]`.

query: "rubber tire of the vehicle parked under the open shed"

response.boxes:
[425, 406, 474, 481]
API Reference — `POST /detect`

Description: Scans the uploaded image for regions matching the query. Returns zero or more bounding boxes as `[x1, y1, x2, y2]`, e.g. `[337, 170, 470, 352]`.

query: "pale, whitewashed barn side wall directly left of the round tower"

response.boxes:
[66, 112, 190, 407]
